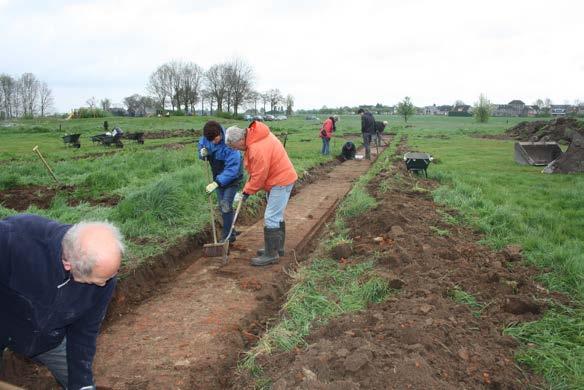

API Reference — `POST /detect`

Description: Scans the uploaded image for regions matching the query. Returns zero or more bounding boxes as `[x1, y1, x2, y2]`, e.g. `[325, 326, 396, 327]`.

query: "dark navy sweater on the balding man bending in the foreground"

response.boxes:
[0, 215, 116, 389]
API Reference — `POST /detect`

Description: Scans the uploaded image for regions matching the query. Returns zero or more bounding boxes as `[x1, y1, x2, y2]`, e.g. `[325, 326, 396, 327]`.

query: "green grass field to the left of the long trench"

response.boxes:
[0, 117, 359, 271]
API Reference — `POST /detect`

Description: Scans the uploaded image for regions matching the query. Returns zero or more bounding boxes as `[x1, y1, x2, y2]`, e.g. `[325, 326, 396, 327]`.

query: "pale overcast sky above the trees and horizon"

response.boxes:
[0, 0, 584, 112]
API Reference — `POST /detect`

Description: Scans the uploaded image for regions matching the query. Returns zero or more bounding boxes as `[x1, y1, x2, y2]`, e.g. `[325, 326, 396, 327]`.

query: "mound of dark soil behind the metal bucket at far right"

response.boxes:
[506, 117, 584, 142]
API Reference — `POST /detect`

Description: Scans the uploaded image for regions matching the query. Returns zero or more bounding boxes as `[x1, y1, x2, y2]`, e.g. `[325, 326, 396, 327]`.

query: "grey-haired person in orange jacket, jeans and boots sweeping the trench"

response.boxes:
[225, 121, 298, 266]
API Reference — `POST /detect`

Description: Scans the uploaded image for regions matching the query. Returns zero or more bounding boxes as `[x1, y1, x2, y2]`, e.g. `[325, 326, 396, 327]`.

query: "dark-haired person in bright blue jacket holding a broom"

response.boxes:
[199, 121, 243, 242]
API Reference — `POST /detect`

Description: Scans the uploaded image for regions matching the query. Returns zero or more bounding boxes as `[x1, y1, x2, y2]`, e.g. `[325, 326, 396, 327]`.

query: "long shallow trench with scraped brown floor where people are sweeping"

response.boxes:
[1, 138, 392, 389]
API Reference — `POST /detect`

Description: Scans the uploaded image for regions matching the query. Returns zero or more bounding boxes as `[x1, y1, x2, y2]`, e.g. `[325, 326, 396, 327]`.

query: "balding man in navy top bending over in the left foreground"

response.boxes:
[0, 215, 124, 389]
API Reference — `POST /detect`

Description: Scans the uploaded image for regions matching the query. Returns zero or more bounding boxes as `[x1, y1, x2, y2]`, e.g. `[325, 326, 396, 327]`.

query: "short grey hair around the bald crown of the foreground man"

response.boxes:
[62, 221, 126, 277]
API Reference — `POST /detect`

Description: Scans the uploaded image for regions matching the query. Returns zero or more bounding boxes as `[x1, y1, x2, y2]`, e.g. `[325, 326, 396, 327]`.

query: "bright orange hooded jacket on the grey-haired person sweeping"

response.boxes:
[243, 121, 298, 195]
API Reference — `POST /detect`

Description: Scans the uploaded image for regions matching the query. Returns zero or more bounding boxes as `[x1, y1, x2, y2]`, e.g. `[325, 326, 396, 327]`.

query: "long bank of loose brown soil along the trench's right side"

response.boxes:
[235, 142, 563, 390]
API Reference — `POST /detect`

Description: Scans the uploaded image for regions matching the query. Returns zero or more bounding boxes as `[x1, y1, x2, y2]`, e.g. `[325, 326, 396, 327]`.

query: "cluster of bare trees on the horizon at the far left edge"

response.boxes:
[0, 73, 53, 119]
